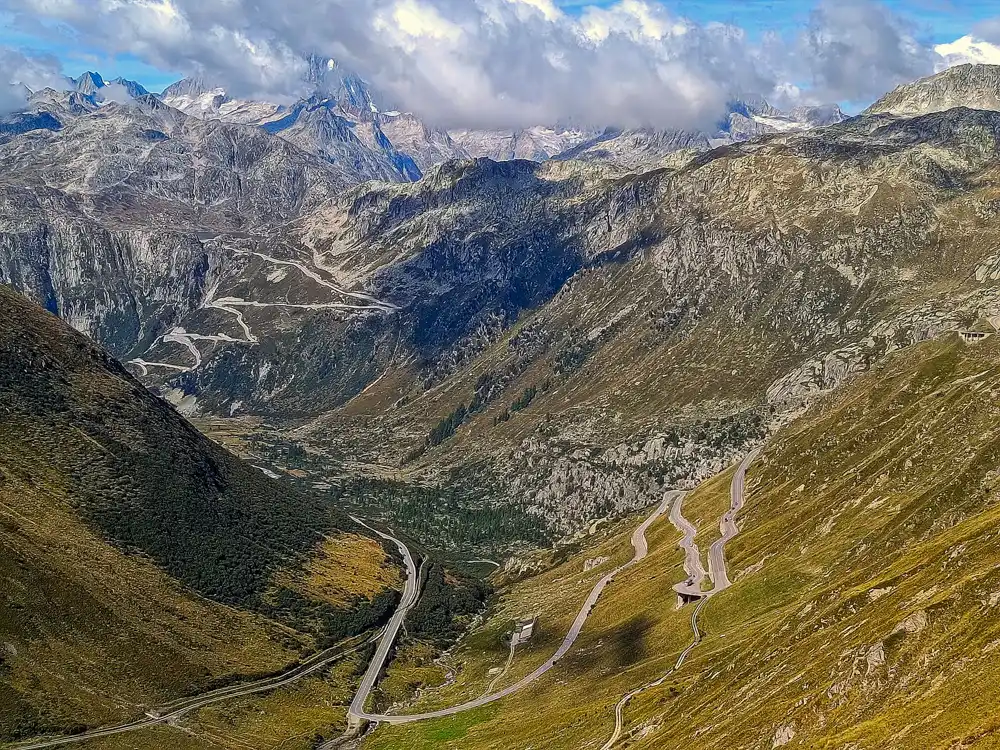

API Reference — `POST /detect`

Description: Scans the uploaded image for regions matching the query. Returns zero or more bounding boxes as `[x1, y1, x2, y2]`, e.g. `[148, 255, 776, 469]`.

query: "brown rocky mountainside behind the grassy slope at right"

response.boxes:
[296, 110, 1000, 531]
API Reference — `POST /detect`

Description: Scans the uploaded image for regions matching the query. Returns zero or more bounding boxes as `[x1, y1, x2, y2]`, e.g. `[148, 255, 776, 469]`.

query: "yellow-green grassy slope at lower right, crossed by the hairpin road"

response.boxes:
[369, 337, 1000, 749]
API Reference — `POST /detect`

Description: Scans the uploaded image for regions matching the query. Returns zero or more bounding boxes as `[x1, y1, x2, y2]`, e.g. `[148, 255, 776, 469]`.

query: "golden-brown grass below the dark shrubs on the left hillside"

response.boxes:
[0, 464, 297, 737]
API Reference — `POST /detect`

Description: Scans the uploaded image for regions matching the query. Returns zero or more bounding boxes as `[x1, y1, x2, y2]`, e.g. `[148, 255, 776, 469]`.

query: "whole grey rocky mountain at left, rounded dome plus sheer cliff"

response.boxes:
[0, 97, 353, 356]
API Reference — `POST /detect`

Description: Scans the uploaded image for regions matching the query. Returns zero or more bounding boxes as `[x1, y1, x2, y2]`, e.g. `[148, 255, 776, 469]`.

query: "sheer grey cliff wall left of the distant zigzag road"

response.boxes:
[0, 185, 221, 357]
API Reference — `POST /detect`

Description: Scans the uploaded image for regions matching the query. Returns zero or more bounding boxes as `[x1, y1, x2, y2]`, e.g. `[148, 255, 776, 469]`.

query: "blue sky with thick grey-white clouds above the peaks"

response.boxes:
[0, 0, 1000, 127]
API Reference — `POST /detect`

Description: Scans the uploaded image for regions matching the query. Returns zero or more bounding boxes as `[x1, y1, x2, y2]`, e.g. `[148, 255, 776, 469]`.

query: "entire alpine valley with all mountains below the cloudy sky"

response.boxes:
[0, 48, 1000, 750]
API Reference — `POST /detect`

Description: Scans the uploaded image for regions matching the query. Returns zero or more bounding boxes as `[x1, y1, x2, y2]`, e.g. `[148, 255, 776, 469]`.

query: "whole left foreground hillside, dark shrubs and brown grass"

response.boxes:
[0, 287, 398, 739]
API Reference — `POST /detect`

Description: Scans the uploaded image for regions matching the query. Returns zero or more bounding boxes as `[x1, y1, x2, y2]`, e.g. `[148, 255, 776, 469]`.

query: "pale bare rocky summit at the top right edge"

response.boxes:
[864, 63, 1000, 117]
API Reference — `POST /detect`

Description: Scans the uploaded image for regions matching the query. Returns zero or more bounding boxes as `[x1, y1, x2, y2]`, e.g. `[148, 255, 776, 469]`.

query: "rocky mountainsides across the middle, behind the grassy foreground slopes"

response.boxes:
[0, 68, 1000, 548]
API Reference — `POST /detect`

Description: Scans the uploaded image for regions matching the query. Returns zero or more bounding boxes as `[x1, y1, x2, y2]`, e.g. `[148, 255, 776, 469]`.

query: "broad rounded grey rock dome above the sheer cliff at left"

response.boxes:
[0, 97, 356, 219]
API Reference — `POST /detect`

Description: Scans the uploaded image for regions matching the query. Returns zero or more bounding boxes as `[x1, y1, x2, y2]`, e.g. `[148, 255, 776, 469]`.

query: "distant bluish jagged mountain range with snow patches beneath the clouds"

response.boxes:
[0, 58, 846, 182]
